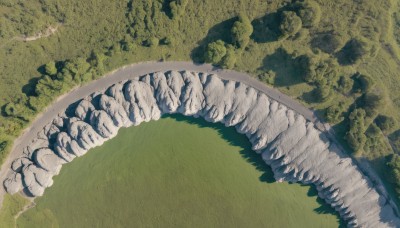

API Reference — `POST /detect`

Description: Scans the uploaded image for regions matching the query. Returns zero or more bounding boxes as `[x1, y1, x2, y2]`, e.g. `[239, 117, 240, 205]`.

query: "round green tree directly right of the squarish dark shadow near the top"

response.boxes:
[279, 11, 302, 38]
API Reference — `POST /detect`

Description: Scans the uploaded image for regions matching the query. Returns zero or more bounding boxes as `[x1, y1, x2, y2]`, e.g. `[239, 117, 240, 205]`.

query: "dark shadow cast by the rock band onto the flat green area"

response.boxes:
[166, 114, 345, 227]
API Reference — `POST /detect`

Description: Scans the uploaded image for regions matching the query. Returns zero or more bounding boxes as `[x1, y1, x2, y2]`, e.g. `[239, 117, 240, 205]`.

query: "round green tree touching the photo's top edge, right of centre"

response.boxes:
[297, 1, 321, 27]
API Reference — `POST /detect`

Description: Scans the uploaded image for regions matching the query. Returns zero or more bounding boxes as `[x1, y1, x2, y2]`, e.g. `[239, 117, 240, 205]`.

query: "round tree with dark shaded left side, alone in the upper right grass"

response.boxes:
[338, 37, 372, 65]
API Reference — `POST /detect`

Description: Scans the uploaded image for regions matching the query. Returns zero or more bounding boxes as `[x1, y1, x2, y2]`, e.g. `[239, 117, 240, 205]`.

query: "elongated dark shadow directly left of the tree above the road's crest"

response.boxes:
[190, 17, 237, 63]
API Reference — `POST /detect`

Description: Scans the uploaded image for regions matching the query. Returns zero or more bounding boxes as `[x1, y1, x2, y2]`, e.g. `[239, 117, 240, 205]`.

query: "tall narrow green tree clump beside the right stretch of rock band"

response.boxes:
[346, 108, 367, 153]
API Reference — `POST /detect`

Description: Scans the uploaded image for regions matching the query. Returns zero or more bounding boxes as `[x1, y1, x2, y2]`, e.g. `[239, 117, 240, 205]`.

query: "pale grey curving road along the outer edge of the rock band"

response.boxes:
[0, 62, 370, 208]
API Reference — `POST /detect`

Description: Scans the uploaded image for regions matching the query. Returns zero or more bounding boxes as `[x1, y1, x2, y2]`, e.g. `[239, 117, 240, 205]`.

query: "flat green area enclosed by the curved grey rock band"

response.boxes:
[17, 116, 339, 228]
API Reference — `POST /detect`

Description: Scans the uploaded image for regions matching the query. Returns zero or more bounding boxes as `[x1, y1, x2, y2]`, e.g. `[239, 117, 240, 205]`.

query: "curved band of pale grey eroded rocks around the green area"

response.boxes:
[4, 71, 400, 227]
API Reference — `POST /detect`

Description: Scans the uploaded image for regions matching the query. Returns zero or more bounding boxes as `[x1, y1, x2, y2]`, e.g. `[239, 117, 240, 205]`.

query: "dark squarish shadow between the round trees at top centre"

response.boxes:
[251, 12, 281, 43]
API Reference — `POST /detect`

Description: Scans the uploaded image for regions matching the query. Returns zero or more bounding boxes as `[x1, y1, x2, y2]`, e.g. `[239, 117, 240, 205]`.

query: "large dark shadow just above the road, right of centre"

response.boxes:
[259, 48, 304, 87]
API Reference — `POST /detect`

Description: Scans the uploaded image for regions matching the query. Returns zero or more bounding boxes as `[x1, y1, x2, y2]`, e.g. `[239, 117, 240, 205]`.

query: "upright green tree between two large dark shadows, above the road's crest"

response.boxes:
[231, 13, 253, 49]
